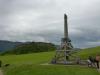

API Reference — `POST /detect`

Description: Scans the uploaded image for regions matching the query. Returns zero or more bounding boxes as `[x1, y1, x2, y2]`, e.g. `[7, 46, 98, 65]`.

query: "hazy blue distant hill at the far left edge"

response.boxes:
[0, 40, 23, 52]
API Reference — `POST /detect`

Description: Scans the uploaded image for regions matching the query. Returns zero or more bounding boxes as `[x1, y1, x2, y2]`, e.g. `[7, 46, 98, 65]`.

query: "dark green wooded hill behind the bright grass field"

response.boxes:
[2, 42, 56, 55]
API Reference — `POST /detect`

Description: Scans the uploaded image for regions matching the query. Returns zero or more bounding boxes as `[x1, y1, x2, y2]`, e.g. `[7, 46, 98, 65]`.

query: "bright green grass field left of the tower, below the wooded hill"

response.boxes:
[0, 52, 54, 65]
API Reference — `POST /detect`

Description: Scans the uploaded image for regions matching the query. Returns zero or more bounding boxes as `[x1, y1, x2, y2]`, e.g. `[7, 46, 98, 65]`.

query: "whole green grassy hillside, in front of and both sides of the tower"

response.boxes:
[0, 47, 100, 75]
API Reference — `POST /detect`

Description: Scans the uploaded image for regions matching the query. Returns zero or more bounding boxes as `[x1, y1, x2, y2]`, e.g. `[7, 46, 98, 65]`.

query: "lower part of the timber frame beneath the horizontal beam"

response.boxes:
[51, 50, 72, 64]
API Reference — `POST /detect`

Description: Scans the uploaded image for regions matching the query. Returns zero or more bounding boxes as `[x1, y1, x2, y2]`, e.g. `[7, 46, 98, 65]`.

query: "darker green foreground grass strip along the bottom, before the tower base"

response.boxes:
[4, 65, 100, 75]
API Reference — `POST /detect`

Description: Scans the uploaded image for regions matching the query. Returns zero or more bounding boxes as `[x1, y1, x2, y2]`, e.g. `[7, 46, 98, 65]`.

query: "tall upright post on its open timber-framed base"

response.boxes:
[51, 14, 73, 64]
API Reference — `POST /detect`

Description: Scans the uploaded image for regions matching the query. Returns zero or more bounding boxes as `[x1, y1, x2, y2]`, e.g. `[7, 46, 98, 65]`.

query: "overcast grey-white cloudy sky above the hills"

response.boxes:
[0, 0, 100, 48]
